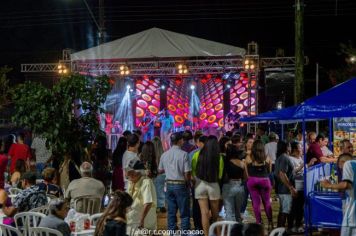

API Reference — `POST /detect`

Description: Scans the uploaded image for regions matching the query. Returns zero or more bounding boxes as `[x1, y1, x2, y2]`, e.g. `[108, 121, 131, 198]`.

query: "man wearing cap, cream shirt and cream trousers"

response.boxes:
[125, 159, 157, 230]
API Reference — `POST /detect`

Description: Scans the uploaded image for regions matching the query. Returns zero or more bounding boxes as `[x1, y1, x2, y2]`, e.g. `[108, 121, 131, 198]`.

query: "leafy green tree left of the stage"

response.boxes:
[13, 74, 111, 155]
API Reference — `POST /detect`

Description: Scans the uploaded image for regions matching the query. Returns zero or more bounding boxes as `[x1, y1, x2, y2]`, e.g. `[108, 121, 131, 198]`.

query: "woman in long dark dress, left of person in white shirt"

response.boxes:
[111, 136, 127, 191]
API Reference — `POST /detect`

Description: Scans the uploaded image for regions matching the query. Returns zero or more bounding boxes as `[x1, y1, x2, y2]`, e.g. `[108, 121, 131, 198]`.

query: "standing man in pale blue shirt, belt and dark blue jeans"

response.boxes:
[158, 132, 192, 233]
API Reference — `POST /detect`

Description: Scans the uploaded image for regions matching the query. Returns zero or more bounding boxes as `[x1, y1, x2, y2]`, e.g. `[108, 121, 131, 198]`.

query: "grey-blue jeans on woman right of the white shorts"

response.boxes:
[222, 181, 245, 223]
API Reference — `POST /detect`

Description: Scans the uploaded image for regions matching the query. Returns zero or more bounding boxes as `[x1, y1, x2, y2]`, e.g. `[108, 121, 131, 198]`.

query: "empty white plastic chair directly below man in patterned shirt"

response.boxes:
[14, 211, 46, 236]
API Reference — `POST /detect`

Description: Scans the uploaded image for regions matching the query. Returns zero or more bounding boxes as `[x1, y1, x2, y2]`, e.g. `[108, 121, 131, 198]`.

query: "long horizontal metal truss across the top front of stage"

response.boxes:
[21, 55, 308, 76]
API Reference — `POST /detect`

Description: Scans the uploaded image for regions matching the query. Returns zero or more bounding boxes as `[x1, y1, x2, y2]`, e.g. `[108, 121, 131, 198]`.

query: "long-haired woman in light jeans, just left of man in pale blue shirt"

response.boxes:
[152, 136, 167, 213]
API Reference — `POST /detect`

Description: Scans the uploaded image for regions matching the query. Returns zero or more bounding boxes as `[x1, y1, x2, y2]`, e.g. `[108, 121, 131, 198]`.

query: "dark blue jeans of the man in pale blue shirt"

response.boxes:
[166, 183, 190, 230]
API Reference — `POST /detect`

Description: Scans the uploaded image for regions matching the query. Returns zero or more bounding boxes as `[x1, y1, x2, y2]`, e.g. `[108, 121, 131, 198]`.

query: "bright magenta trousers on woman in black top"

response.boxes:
[247, 176, 272, 224]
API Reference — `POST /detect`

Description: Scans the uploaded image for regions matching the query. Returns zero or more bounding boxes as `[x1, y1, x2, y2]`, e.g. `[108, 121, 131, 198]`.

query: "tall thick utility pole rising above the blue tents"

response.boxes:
[294, 0, 304, 105]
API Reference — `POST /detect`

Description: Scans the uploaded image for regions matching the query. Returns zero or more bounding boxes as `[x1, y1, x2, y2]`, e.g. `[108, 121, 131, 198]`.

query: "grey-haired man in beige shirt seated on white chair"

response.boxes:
[65, 162, 105, 213]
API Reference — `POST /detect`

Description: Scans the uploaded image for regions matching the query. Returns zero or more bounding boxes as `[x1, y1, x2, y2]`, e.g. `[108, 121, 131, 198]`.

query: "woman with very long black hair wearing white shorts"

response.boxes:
[193, 136, 224, 235]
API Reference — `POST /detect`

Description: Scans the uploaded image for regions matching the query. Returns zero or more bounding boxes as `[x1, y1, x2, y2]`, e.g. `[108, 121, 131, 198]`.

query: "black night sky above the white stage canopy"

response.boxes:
[0, 0, 356, 95]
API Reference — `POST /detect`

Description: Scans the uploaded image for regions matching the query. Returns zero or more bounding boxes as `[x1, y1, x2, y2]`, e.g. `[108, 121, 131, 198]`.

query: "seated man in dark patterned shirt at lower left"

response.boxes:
[2, 172, 47, 217]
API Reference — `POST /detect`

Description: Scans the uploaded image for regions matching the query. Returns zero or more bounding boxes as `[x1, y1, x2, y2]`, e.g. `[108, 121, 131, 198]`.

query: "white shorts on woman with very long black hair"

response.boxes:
[195, 180, 221, 200]
